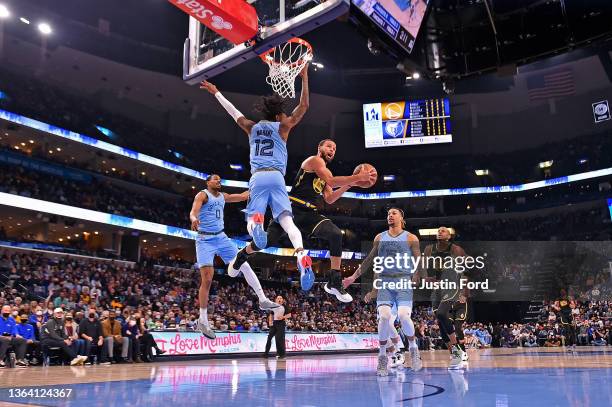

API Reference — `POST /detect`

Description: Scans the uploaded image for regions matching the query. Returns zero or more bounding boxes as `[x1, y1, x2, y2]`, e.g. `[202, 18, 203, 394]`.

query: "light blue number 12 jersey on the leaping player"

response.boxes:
[249, 120, 287, 175]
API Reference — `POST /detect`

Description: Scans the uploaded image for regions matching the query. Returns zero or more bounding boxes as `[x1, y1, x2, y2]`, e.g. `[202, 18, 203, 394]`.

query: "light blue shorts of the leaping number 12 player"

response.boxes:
[246, 171, 292, 220]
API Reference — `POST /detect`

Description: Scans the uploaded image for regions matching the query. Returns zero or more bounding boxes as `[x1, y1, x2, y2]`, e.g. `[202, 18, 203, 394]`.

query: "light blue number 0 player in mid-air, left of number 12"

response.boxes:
[189, 174, 278, 339]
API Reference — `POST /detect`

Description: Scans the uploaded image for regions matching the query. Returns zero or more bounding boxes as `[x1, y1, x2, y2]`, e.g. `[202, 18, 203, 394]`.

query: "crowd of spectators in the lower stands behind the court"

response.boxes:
[0, 245, 612, 367]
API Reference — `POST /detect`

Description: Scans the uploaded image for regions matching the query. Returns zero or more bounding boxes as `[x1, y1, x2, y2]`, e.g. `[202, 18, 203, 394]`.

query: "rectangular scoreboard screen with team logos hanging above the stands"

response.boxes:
[363, 98, 453, 148]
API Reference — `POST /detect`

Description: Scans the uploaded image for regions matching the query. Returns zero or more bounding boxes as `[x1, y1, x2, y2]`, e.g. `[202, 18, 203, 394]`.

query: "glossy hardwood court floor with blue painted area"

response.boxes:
[0, 347, 612, 407]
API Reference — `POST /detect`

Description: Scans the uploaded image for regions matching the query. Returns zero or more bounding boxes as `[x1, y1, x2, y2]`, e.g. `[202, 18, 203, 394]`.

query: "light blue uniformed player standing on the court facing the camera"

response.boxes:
[343, 208, 423, 376]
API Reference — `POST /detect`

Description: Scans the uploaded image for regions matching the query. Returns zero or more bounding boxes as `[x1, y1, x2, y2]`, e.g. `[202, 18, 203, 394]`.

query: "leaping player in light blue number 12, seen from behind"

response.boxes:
[200, 69, 314, 294]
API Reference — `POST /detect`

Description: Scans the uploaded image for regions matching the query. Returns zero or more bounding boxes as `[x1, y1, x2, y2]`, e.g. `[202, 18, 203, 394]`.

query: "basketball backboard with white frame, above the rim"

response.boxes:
[183, 0, 350, 85]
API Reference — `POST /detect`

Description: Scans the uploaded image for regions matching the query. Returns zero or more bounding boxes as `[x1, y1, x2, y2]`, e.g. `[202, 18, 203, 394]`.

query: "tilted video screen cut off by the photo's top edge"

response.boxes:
[353, 0, 429, 53]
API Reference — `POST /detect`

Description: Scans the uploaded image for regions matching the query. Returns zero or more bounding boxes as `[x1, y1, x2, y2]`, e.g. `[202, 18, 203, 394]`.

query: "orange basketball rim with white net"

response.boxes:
[260, 38, 312, 98]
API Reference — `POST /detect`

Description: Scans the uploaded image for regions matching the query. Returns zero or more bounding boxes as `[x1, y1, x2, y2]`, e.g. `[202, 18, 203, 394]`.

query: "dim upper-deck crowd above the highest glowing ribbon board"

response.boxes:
[0, 70, 612, 191]
